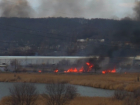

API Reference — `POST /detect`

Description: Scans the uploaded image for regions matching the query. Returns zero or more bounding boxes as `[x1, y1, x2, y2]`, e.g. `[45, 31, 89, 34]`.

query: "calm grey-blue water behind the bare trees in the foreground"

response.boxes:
[0, 82, 114, 99]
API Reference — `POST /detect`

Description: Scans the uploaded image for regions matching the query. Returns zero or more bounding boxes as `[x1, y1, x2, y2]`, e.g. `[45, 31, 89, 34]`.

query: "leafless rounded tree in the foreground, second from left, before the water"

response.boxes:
[43, 81, 77, 105]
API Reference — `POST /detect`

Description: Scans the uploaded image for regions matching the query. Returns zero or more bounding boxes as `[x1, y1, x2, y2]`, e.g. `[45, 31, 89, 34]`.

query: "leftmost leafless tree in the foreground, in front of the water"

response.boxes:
[9, 83, 38, 105]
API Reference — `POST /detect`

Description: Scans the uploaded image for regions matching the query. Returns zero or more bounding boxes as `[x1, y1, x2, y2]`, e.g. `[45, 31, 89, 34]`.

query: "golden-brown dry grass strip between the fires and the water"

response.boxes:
[0, 73, 140, 91]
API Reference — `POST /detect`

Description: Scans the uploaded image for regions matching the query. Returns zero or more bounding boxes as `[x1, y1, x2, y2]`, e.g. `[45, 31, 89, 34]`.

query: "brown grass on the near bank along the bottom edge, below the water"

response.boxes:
[0, 96, 123, 105]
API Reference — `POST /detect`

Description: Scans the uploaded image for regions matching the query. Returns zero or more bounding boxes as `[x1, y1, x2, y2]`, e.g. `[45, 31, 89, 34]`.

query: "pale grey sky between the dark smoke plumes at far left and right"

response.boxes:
[0, 0, 139, 19]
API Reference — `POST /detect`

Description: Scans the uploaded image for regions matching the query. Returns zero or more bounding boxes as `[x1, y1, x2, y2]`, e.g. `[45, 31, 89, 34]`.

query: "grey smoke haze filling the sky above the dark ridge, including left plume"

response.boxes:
[0, 0, 138, 19]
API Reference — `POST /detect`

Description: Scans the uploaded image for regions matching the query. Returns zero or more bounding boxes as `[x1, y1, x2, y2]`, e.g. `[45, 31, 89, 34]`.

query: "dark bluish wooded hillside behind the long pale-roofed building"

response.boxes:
[0, 18, 140, 56]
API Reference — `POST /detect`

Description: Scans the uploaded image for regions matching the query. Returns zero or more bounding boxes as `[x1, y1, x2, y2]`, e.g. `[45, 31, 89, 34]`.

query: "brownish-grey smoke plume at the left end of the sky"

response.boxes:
[0, 0, 34, 17]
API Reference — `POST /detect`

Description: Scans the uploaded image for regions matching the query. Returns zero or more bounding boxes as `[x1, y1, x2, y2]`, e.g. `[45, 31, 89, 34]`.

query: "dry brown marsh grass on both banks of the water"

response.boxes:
[0, 73, 140, 105]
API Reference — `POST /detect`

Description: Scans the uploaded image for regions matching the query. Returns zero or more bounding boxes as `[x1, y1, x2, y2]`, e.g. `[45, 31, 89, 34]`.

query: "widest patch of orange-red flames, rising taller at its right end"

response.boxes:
[64, 62, 93, 73]
